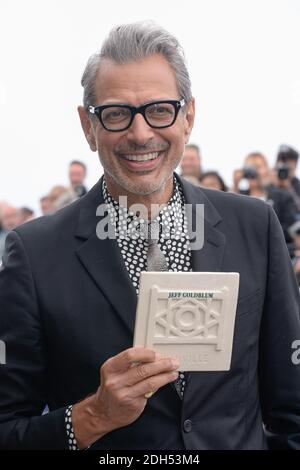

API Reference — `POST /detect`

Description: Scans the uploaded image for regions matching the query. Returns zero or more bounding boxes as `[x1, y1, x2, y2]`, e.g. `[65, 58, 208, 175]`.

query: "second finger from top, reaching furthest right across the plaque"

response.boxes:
[120, 358, 179, 386]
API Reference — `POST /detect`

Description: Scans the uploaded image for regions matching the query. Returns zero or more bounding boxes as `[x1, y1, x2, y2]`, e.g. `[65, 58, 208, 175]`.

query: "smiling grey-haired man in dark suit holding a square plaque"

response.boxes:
[0, 23, 300, 450]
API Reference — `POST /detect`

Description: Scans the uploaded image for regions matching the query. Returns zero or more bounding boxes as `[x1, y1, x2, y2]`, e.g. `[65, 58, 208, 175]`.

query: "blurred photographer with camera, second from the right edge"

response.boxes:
[233, 152, 297, 244]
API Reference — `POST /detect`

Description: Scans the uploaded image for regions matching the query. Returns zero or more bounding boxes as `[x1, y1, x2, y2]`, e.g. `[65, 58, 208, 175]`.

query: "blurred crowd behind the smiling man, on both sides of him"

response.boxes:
[0, 144, 300, 286]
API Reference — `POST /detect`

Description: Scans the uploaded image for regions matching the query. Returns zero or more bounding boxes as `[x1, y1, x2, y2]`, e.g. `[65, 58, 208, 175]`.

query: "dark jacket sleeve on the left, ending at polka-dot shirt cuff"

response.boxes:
[0, 231, 67, 449]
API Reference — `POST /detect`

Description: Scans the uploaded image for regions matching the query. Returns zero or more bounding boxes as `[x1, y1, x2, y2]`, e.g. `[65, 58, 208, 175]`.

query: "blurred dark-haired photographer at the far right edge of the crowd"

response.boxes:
[273, 145, 300, 212]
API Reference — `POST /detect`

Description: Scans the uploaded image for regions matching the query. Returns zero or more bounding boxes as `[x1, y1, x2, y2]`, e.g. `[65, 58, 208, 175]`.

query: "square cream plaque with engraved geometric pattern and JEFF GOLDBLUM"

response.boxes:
[134, 271, 239, 371]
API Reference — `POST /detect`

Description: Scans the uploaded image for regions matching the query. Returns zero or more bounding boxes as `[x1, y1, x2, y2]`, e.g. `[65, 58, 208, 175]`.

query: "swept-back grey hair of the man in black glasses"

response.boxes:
[81, 21, 192, 109]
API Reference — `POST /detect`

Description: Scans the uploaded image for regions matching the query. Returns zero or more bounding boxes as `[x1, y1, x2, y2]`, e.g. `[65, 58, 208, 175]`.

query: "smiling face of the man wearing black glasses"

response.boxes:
[78, 55, 194, 202]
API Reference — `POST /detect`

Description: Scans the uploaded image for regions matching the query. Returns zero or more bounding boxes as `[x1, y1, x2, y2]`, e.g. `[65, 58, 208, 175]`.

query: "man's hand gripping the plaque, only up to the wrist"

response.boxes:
[94, 347, 179, 430]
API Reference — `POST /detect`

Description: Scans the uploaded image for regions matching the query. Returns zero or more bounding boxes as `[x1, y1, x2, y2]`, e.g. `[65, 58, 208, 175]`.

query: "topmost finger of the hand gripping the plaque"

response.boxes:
[105, 347, 157, 372]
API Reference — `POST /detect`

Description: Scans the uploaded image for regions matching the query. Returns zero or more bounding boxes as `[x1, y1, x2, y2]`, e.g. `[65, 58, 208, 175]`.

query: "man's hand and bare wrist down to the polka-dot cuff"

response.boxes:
[72, 347, 179, 448]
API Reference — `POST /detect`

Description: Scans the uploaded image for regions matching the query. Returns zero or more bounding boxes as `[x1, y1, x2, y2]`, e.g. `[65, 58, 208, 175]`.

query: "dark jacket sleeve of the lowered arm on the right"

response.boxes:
[259, 208, 300, 449]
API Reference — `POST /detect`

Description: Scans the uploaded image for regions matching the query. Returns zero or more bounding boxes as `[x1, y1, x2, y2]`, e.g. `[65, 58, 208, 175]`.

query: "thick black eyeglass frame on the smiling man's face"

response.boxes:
[88, 98, 186, 132]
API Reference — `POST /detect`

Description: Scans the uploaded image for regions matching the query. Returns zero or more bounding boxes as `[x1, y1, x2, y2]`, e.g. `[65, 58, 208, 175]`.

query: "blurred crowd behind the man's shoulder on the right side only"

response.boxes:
[181, 144, 300, 286]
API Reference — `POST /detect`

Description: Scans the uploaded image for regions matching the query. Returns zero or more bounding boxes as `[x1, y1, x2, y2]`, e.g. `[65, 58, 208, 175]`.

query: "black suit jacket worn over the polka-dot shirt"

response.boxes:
[0, 174, 300, 449]
